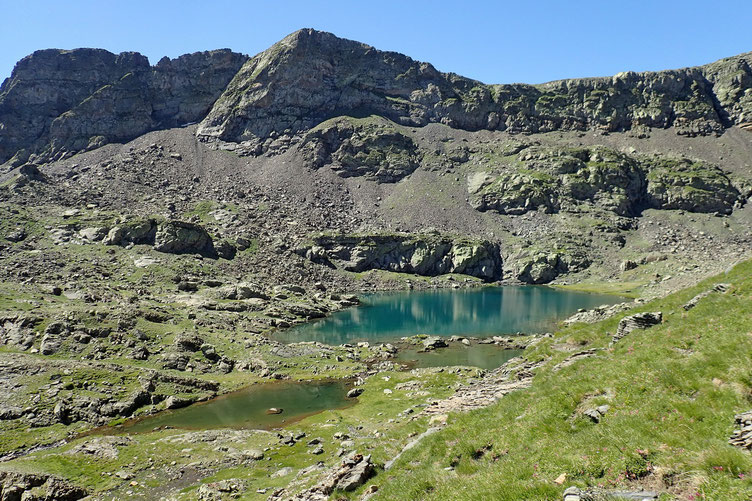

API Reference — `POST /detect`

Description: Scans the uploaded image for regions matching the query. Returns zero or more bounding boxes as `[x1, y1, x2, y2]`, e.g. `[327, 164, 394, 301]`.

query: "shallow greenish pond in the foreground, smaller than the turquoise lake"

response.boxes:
[115, 381, 356, 433]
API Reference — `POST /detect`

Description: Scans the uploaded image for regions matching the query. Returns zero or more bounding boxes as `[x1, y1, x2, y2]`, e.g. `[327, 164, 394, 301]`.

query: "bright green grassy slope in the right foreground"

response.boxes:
[373, 262, 752, 500]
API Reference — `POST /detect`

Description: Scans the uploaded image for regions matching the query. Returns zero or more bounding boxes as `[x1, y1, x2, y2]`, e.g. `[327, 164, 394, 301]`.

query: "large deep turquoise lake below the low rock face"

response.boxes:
[274, 286, 623, 345]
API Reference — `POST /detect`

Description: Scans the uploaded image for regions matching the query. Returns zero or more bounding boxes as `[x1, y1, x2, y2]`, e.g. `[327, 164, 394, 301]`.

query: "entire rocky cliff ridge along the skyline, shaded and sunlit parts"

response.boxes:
[0, 29, 752, 165]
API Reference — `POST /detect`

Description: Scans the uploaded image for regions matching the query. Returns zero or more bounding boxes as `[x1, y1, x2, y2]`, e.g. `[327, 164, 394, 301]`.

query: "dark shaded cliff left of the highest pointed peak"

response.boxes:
[0, 49, 246, 164]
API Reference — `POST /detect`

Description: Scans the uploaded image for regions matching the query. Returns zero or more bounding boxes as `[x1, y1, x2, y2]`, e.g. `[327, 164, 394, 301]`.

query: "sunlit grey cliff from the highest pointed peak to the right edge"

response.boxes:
[199, 30, 752, 146]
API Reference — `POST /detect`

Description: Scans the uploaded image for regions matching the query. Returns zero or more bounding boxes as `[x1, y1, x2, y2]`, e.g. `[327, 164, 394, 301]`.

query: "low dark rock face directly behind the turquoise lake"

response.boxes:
[297, 234, 502, 281]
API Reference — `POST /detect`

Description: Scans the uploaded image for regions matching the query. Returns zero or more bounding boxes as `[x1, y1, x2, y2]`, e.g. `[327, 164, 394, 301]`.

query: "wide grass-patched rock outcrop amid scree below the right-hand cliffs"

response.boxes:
[468, 147, 749, 216]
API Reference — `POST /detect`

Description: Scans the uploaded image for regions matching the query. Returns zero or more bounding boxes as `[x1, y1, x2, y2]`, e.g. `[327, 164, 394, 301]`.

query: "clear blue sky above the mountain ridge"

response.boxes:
[0, 0, 752, 83]
